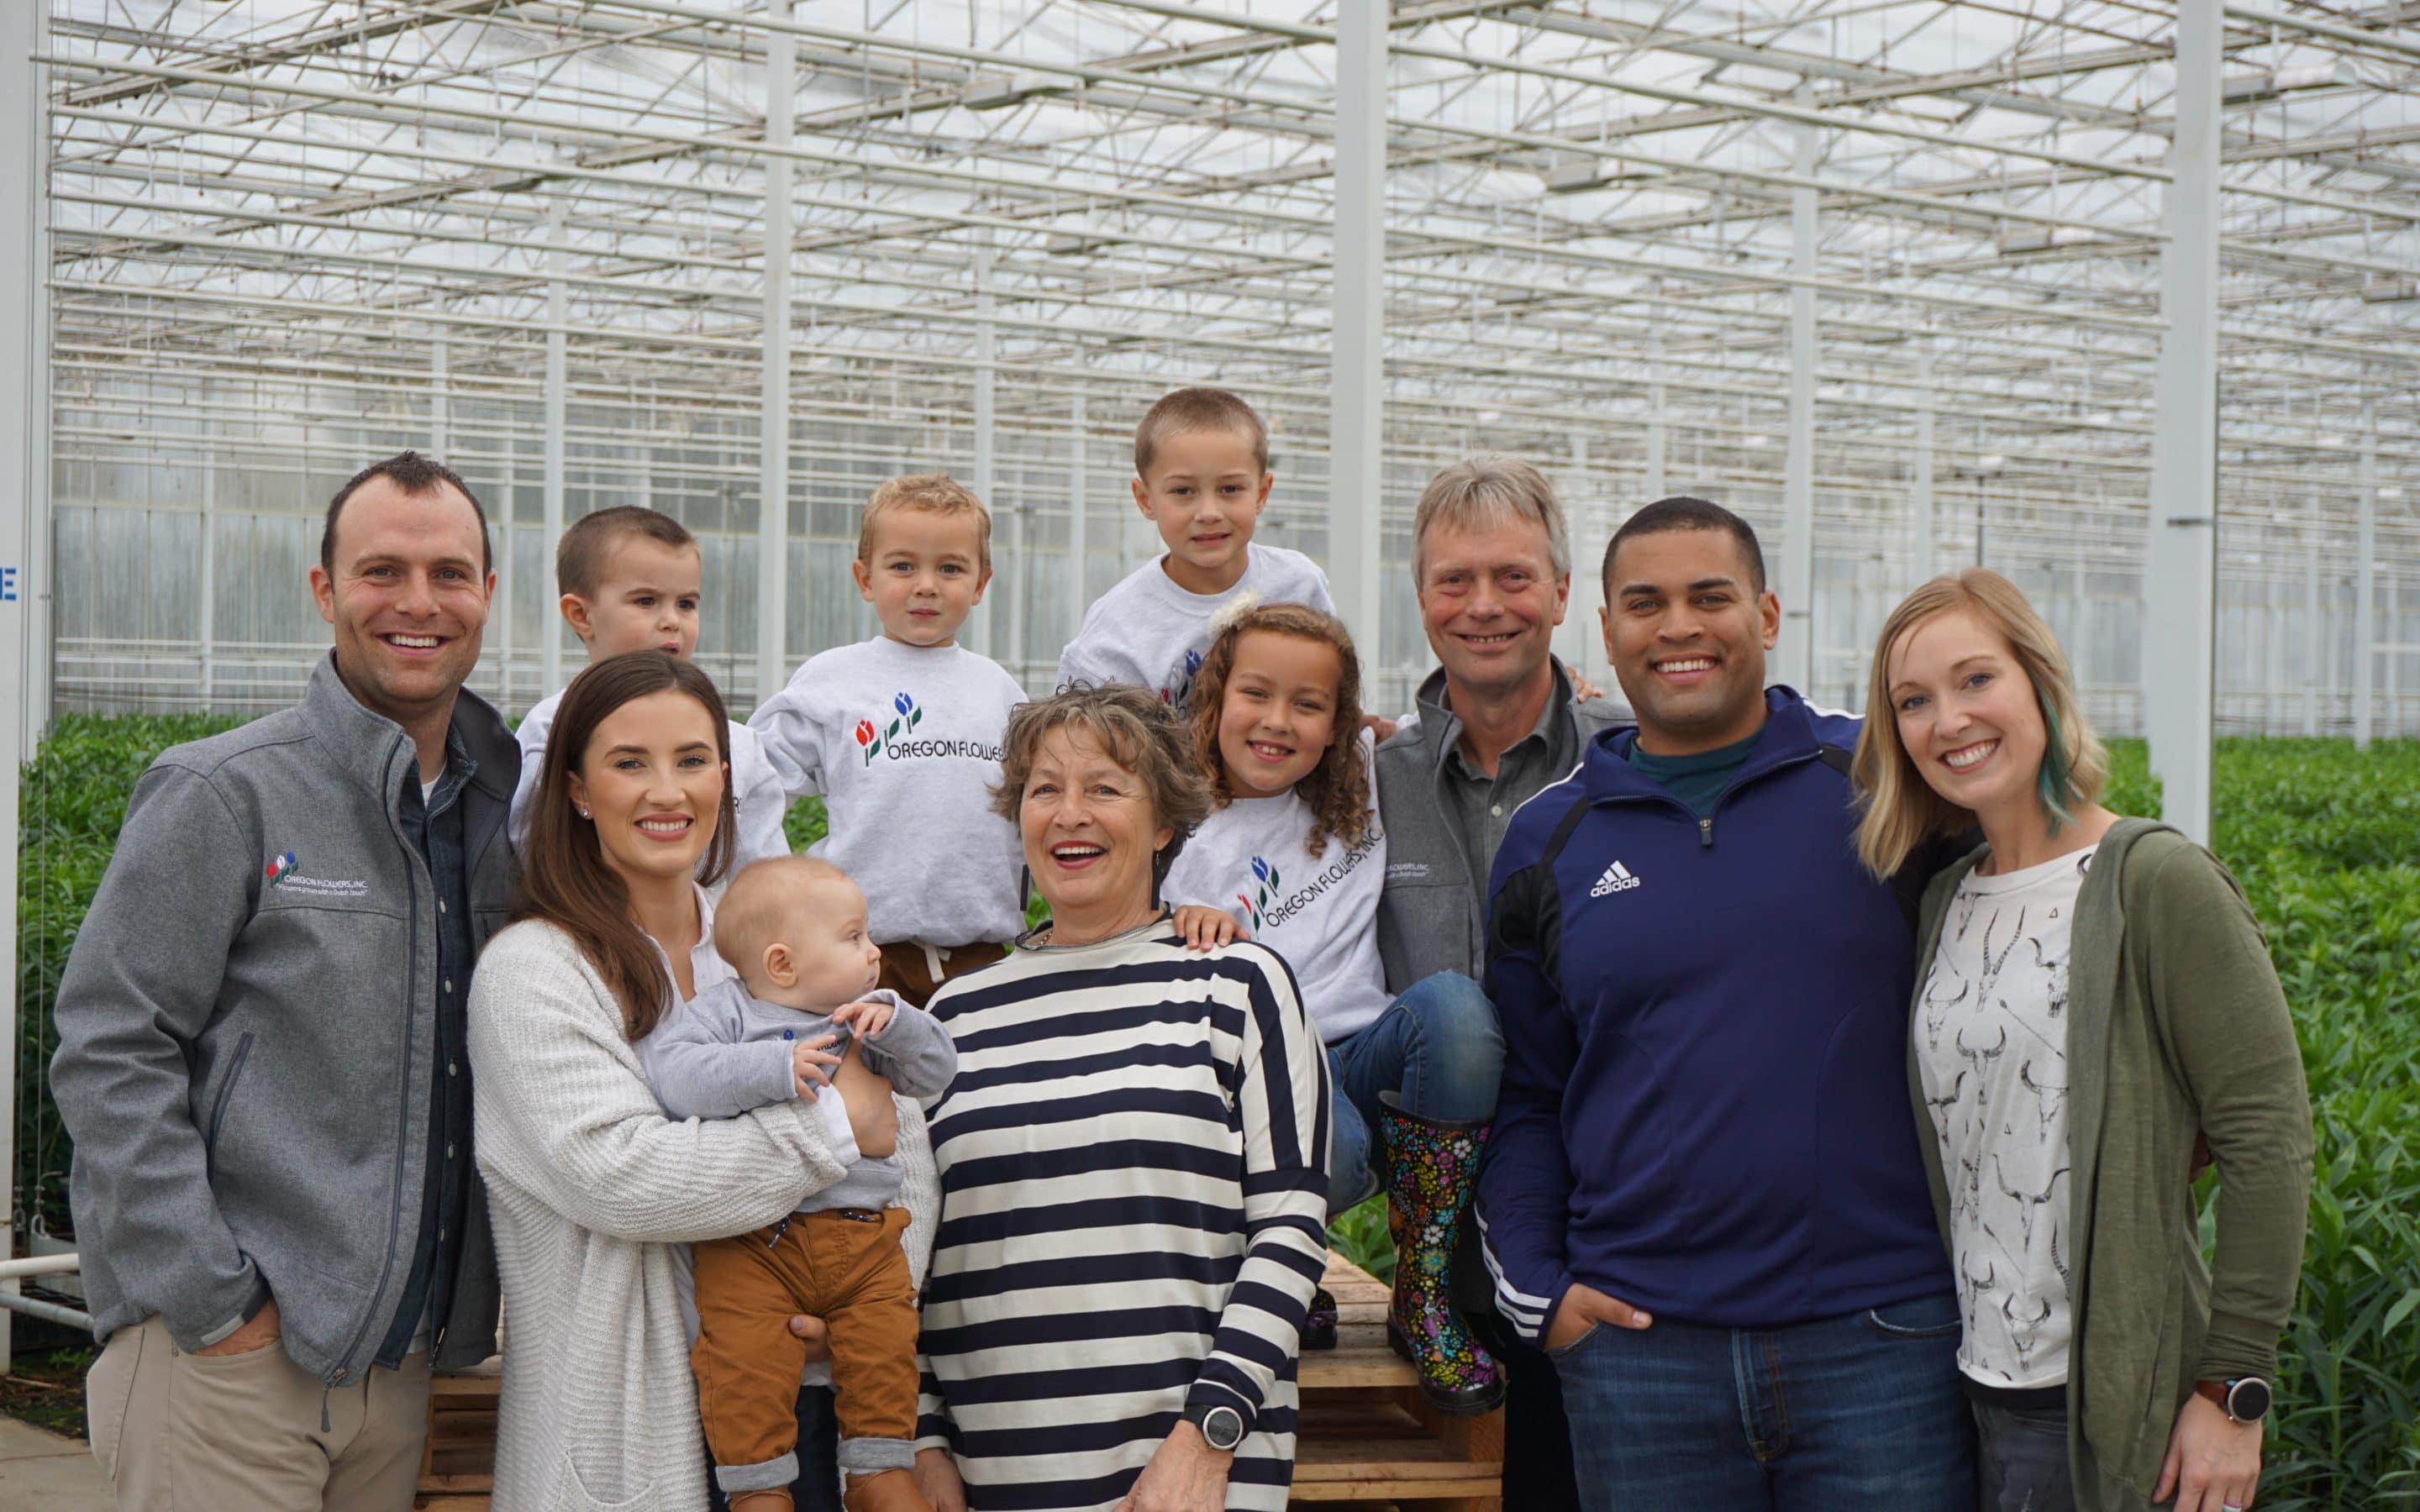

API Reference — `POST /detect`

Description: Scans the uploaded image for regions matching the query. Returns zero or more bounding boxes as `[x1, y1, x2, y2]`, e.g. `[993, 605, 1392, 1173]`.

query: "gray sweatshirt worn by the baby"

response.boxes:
[639, 978, 958, 1212]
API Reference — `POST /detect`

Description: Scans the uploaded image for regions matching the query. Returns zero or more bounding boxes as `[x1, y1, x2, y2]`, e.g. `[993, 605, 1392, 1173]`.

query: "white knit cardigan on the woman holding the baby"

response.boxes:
[470, 924, 937, 1512]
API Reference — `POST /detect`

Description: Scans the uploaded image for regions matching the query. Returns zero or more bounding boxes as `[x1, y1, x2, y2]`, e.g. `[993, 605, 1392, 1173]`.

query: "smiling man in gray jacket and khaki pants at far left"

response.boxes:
[50, 453, 520, 1512]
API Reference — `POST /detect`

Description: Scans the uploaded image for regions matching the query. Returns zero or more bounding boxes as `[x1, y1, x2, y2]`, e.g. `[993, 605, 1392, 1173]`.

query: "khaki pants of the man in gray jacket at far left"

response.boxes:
[85, 1319, 429, 1512]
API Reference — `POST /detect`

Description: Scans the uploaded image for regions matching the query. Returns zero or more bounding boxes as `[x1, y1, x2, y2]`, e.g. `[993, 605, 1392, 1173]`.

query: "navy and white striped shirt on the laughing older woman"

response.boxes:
[919, 921, 1328, 1512]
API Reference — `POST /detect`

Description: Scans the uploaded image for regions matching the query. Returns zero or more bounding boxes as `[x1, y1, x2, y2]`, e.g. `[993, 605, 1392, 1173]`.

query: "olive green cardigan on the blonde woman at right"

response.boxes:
[1907, 820, 2311, 1512]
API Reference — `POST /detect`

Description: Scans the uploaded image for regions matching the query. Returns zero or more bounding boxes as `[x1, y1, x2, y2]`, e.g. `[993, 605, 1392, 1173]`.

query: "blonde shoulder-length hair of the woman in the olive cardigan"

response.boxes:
[1851, 566, 2110, 878]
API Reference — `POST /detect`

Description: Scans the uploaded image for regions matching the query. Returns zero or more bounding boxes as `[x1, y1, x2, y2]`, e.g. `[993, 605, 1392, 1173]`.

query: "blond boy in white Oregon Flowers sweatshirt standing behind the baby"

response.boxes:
[748, 474, 1026, 1004]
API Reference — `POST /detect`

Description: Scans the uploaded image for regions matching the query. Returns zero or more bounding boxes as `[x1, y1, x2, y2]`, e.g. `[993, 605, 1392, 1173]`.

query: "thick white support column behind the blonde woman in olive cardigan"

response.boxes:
[2142, 5, 2222, 844]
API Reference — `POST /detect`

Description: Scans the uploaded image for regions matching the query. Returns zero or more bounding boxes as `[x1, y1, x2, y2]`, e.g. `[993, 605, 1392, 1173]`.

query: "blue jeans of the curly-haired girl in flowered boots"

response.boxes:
[1328, 970, 1505, 1217]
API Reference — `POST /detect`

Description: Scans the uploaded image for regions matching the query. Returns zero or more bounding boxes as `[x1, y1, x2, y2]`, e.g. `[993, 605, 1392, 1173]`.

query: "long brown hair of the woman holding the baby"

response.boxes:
[513, 648, 734, 1040]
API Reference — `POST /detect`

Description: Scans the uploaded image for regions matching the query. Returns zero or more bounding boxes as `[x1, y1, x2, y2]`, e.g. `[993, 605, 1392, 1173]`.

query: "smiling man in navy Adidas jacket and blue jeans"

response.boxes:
[1479, 498, 1975, 1512]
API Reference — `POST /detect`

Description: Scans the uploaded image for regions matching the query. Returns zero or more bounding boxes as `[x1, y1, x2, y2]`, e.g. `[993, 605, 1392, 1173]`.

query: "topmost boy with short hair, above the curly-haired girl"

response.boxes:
[1058, 390, 1336, 714]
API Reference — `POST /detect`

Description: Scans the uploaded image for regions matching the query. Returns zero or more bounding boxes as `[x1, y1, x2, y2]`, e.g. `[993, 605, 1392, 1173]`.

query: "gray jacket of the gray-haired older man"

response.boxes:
[1377, 665, 1631, 995]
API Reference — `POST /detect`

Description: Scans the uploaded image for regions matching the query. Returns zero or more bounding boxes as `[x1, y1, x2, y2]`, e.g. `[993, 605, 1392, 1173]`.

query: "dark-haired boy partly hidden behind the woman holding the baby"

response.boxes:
[506, 503, 789, 871]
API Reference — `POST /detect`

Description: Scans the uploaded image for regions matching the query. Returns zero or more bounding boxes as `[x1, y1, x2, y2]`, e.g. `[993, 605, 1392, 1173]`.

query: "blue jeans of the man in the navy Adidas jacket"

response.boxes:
[1554, 1292, 1975, 1512]
